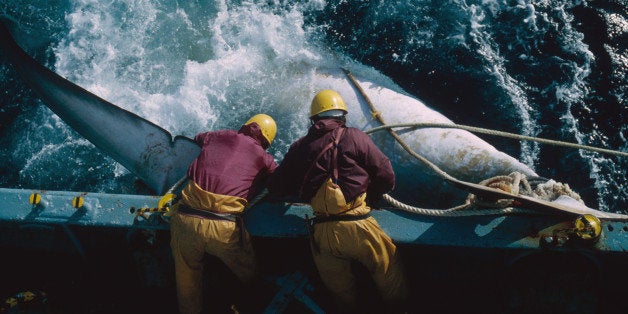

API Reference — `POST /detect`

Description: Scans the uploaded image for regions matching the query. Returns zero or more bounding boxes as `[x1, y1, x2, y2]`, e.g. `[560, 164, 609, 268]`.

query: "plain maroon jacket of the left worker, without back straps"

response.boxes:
[188, 123, 277, 200]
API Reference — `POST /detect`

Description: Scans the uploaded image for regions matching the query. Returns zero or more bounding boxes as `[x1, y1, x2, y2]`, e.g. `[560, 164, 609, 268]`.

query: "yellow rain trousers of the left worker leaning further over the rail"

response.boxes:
[170, 182, 257, 314]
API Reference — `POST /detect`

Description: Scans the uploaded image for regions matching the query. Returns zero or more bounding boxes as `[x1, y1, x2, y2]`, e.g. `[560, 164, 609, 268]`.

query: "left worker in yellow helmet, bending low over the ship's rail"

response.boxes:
[170, 114, 277, 313]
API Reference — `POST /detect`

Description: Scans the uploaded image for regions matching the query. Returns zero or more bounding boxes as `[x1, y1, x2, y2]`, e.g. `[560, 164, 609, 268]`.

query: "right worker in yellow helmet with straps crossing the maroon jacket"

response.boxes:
[268, 90, 407, 313]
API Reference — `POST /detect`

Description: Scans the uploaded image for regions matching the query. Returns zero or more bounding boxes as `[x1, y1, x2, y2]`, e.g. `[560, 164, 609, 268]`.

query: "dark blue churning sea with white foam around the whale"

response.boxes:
[0, 0, 628, 213]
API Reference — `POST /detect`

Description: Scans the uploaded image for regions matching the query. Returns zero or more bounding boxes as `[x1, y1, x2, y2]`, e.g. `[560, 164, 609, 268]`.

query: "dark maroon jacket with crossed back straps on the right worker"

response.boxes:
[268, 119, 395, 202]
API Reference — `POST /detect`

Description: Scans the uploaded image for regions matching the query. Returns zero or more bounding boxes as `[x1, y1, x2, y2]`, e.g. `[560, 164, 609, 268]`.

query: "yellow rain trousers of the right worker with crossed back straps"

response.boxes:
[312, 194, 407, 311]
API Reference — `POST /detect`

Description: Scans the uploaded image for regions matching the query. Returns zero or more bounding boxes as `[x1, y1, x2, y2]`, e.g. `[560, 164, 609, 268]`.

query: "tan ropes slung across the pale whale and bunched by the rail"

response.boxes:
[343, 69, 628, 218]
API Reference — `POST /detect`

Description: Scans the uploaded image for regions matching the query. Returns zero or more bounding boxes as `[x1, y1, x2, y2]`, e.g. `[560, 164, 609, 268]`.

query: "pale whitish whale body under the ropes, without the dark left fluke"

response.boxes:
[311, 69, 538, 205]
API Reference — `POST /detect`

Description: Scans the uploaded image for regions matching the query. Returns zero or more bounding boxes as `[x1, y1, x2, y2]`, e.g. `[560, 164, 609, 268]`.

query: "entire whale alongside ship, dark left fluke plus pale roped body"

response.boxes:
[0, 18, 537, 205]
